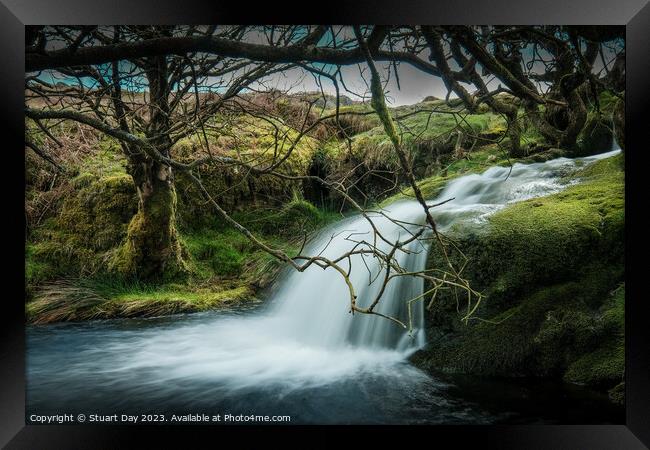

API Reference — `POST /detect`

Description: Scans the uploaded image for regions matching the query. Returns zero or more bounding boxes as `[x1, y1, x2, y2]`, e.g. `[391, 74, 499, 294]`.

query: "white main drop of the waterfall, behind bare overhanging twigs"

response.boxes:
[271, 201, 428, 350]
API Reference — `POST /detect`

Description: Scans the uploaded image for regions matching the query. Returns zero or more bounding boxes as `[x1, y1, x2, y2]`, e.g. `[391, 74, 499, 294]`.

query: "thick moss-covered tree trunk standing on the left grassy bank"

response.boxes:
[116, 56, 185, 279]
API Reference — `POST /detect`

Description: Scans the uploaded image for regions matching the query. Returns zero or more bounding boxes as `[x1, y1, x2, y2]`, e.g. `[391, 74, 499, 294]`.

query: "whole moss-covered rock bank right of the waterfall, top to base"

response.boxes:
[415, 156, 625, 400]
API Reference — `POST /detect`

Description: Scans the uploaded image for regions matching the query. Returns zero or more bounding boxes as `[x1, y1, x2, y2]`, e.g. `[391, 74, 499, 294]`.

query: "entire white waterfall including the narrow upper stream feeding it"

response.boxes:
[258, 150, 618, 352]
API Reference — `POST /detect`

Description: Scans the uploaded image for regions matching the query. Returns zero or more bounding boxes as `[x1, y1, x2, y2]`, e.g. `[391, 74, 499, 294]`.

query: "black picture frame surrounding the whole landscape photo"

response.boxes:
[0, 0, 650, 449]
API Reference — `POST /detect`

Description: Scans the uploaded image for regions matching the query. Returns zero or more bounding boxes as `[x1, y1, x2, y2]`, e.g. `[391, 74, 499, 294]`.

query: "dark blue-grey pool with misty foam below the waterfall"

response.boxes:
[27, 311, 624, 424]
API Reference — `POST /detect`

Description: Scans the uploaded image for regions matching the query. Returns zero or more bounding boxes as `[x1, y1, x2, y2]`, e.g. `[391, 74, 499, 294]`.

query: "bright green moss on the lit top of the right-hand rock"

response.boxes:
[440, 153, 625, 297]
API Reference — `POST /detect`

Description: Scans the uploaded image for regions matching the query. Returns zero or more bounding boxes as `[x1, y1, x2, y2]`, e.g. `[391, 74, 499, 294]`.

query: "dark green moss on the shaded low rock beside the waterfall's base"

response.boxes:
[422, 282, 591, 376]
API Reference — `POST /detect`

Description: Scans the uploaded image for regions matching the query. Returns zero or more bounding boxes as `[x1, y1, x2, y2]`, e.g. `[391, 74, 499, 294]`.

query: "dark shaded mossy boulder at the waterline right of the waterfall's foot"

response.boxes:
[418, 280, 620, 376]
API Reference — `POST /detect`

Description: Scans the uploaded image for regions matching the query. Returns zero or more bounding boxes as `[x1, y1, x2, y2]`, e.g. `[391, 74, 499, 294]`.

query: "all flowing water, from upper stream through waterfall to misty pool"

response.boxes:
[27, 150, 617, 423]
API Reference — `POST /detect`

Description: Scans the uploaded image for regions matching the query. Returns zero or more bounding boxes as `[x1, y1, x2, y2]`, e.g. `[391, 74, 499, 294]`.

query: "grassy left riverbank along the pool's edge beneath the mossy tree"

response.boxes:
[26, 200, 341, 324]
